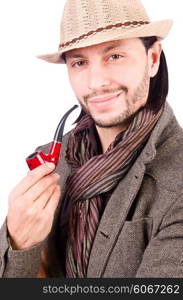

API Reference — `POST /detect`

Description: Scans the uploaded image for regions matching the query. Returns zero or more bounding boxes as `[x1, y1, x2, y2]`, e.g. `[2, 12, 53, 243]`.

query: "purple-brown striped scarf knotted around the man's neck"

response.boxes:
[66, 107, 164, 278]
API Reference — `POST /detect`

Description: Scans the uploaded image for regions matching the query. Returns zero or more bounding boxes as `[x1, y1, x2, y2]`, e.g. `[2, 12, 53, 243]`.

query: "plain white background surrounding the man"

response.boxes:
[0, 0, 183, 225]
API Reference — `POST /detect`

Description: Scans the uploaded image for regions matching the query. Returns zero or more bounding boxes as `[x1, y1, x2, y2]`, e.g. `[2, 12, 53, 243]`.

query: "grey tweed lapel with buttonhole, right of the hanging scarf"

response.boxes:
[87, 157, 145, 277]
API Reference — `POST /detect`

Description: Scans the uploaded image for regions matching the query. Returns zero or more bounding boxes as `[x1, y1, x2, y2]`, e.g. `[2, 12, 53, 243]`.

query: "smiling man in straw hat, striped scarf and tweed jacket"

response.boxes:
[0, 0, 183, 277]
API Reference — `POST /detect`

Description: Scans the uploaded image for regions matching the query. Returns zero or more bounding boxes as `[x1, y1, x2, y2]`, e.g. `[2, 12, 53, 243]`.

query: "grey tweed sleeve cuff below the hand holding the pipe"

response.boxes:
[0, 220, 46, 278]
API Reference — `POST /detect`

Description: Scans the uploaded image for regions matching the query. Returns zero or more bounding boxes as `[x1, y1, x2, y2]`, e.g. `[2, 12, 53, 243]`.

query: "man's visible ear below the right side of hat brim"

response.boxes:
[148, 41, 162, 77]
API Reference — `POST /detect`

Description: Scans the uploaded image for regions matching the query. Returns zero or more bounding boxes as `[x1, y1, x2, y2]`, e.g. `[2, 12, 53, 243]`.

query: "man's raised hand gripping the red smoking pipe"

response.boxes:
[7, 163, 60, 249]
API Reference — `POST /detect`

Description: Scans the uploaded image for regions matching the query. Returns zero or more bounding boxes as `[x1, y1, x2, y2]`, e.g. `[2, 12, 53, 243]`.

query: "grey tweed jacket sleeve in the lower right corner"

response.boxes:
[136, 192, 183, 278]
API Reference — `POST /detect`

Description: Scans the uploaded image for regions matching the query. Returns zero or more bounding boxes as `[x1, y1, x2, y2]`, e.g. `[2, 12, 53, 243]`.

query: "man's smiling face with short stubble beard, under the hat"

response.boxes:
[66, 38, 159, 128]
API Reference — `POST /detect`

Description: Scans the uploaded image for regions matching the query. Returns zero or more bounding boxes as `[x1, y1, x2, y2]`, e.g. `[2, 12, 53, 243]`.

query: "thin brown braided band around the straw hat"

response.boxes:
[59, 21, 150, 49]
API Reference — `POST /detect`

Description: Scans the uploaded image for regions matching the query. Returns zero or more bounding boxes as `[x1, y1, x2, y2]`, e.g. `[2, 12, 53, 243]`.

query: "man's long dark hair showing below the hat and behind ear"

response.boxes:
[66, 36, 169, 123]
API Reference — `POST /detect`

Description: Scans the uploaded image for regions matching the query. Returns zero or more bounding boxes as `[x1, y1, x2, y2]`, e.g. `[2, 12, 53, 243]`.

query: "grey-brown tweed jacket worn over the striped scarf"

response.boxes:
[0, 103, 183, 278]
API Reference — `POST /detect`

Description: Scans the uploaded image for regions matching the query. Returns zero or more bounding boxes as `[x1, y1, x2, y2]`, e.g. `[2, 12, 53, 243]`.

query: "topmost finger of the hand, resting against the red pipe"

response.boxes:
[10, 163, 55, 198]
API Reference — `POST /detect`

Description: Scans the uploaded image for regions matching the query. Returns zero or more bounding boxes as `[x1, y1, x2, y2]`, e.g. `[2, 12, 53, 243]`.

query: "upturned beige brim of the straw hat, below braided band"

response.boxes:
[37, 19, 173, 64]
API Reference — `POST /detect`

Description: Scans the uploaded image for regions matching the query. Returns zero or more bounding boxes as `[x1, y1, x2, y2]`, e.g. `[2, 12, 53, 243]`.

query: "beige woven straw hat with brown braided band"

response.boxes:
[38, 0, 173, 63]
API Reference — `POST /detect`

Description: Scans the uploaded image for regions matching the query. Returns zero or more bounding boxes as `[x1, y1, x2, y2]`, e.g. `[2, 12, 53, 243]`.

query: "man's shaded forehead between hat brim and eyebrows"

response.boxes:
[65, 38, 142, 58]
